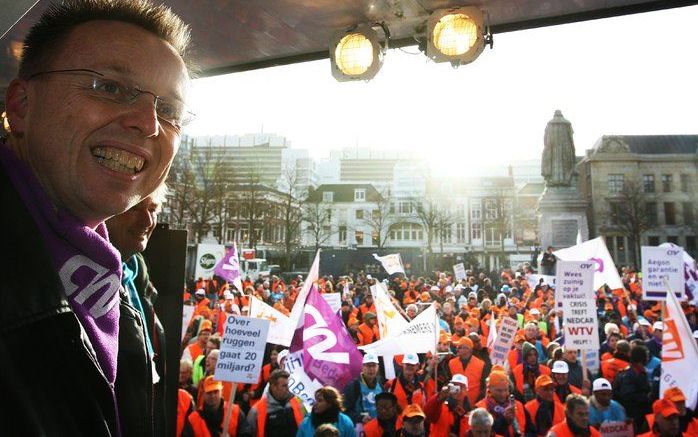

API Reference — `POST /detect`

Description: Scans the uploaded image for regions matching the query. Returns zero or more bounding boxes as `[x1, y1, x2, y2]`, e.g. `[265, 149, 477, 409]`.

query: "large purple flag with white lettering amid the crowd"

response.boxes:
[291, 285, 362, 389]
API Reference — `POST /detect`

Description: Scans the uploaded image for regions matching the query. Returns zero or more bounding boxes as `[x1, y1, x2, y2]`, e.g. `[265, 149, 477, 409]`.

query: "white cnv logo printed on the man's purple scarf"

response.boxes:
[58, 255, 121, 319]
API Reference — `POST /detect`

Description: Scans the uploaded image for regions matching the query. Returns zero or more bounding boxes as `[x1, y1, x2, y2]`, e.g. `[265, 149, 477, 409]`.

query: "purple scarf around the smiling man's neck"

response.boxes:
[0, 143, 121, 384]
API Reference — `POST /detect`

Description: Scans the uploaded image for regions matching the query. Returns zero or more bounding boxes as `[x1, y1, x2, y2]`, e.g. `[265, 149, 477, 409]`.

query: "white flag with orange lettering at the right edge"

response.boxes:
[659, 282, 698, 409]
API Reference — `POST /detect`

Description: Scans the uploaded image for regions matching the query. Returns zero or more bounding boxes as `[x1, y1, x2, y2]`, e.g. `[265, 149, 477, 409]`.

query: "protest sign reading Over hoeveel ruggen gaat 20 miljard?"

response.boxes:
[214, 314, 269, 384]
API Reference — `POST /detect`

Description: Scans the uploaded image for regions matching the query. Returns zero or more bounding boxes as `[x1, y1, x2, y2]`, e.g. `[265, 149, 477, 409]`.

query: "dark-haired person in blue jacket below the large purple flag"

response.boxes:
[294, 386, 356, 437]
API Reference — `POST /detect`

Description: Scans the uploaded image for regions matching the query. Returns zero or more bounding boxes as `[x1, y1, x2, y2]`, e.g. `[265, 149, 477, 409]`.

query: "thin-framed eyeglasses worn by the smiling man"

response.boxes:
[29, 68, 196, 130]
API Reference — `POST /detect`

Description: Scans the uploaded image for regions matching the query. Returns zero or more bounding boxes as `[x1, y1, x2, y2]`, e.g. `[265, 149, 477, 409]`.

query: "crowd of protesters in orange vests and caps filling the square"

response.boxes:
[178, 265, 698, 437]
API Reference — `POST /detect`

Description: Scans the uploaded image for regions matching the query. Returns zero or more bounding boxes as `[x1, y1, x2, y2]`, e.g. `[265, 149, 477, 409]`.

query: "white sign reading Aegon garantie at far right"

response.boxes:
[640, 246, 685, 300]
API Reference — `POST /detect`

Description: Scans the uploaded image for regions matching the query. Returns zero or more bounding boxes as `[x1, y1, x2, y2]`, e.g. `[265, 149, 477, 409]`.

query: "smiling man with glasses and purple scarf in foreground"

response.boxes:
[0, 0, 191, 436]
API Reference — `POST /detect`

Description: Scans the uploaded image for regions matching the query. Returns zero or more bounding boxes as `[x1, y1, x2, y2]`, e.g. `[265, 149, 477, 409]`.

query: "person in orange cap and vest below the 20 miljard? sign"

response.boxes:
[182, 376, 247, 437]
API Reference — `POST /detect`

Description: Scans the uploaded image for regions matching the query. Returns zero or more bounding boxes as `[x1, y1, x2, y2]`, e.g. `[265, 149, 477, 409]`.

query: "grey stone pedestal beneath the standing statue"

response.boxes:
[537, 186, 589, 250]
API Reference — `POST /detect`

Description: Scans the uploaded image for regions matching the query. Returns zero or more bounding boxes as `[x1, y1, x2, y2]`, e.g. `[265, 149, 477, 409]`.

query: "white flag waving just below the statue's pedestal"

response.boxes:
[553, 237, 623, 290]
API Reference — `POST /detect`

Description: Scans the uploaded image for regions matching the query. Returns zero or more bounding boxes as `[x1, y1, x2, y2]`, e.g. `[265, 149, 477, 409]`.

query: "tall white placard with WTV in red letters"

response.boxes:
[555, 260, 599, 350]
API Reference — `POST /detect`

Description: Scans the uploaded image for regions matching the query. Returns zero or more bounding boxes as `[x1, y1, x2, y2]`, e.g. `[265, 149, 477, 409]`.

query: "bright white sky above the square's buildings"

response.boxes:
[188, 6, 698, 168]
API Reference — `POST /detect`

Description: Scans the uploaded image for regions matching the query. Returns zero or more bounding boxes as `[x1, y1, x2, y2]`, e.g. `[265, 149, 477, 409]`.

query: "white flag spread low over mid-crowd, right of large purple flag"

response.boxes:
[359, 304, 439, 356]
